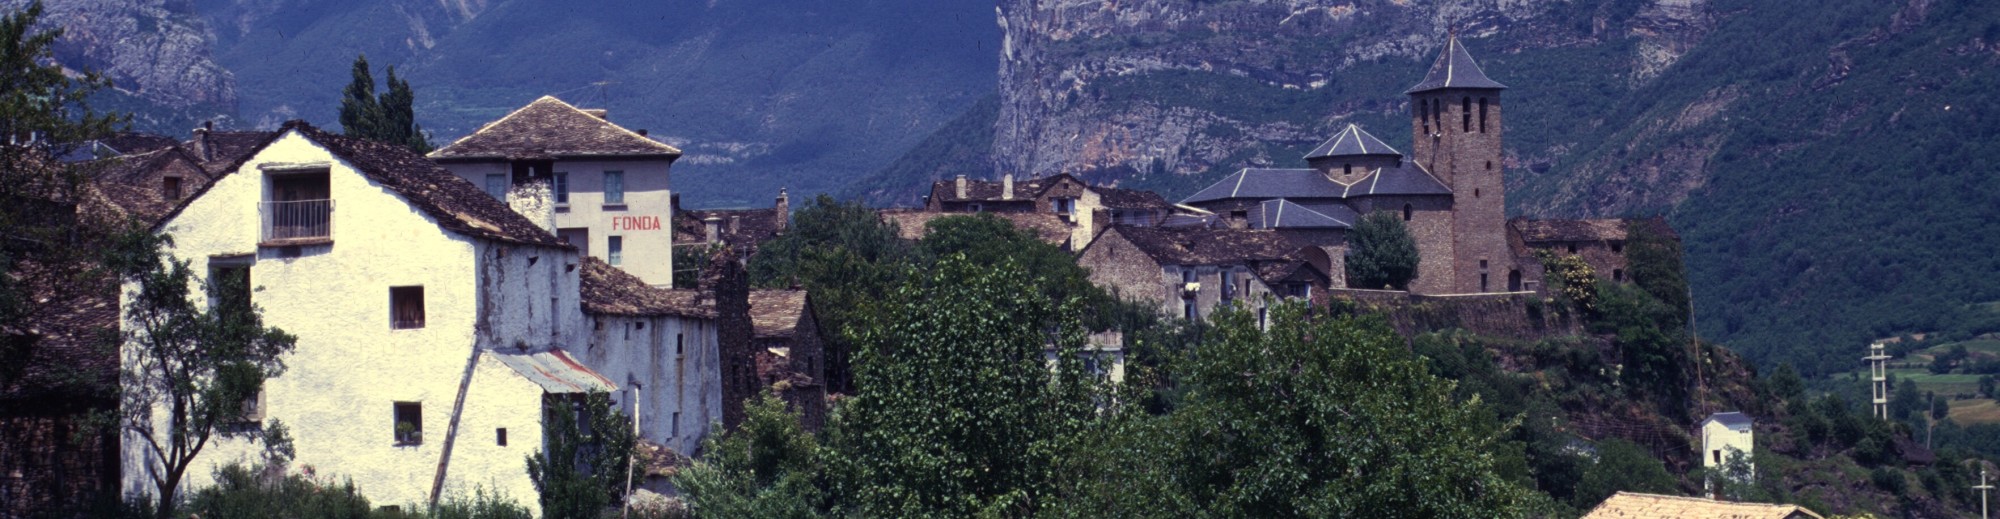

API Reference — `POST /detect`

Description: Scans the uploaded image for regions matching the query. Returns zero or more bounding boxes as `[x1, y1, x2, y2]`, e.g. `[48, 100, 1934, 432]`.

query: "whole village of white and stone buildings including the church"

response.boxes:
[0, 2, 1990, 517]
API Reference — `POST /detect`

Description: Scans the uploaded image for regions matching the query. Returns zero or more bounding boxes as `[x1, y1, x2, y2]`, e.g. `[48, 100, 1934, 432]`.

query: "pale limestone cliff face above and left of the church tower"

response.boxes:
[994, 0, 1718, 198]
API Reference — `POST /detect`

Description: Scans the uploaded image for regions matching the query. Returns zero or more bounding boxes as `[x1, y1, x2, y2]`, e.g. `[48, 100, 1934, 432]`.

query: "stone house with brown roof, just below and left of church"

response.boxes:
[1076, 226, 1332, 319]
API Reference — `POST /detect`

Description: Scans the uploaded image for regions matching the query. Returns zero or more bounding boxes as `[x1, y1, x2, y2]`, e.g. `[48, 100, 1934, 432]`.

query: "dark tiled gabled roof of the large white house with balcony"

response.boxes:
[160, 120, 570, 248]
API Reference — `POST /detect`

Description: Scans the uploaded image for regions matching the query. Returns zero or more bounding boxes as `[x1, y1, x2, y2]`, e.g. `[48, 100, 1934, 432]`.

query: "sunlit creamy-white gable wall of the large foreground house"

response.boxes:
[124, 132, 576, 507]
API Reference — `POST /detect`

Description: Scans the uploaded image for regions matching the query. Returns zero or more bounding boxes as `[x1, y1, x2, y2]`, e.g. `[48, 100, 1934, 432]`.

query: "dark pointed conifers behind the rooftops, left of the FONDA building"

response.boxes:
[340, 56, 434, 154]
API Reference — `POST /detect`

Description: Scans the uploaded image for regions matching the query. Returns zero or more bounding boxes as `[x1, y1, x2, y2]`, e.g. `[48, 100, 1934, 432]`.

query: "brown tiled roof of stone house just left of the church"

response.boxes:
[1092, 226, 1298, 265]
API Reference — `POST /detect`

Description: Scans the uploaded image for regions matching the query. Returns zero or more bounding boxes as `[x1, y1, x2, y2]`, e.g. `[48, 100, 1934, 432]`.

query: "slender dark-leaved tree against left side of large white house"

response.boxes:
[118, 236, 298, 517]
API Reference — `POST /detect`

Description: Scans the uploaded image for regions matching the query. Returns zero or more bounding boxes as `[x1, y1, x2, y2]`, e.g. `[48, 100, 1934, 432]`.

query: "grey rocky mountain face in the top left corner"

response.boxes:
[0, 0, 236, 108]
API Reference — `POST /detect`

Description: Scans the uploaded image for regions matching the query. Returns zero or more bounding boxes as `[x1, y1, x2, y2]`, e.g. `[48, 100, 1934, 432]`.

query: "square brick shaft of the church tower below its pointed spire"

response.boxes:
[1410, 88, 1514, 293]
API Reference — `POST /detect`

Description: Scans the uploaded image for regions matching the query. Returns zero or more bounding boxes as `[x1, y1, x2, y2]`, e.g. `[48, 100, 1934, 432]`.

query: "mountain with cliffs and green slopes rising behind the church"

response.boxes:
[854, 0, 2000, 373]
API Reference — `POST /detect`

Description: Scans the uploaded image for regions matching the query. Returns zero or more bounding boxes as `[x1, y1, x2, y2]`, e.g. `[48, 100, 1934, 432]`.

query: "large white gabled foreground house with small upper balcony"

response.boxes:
[122, 122, 720, 507]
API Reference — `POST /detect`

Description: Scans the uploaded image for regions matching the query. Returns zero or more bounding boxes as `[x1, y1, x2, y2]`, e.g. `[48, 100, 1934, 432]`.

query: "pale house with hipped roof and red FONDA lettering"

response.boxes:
[430, 96, 680, 285]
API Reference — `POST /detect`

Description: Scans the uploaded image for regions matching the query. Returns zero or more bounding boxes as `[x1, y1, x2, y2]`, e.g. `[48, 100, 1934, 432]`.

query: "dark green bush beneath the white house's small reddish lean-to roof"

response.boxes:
[528, 391, 638, 519]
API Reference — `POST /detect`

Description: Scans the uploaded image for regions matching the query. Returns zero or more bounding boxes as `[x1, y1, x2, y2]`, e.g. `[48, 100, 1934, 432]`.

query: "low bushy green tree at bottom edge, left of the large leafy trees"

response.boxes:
[674, 391, 826, 519]
